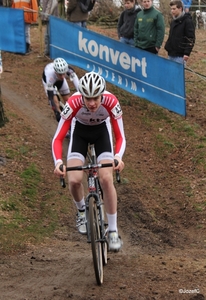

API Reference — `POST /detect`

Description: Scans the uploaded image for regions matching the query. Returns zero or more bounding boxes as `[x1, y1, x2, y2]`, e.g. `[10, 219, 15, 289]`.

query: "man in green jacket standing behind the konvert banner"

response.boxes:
[134, 0, 165, 54]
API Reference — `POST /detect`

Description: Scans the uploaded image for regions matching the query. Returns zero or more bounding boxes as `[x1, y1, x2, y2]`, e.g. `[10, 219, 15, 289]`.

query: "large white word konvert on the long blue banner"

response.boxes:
[78, 31, 147, 77]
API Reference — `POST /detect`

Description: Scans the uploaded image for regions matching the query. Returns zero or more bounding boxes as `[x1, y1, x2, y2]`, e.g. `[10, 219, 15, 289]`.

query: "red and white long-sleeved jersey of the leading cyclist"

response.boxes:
[52, 91, 126, 165]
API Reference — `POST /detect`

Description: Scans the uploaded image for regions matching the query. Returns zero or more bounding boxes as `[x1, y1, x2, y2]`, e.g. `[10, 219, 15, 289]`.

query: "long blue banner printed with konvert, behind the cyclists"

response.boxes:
[50, 16, 186, 116]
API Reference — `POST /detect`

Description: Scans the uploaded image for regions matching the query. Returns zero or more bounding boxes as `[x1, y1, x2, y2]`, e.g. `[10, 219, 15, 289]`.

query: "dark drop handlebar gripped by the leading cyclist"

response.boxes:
[59, 159, 120, 188]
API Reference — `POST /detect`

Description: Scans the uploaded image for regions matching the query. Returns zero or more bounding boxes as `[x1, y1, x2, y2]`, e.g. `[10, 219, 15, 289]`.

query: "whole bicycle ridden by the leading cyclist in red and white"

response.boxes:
[60, 145, 120, 285]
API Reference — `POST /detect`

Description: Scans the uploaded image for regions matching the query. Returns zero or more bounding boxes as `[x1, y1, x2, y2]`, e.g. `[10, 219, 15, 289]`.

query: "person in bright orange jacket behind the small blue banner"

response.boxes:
[12, 0, 38, 54]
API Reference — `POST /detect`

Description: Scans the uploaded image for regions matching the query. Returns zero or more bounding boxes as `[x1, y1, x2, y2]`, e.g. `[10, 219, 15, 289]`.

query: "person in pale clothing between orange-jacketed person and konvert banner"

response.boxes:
[40, 0, 59, 56]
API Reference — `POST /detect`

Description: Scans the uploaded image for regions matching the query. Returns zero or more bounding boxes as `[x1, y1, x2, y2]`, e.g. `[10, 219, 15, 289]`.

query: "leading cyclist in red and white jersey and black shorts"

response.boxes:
[52, 72, 126, 251]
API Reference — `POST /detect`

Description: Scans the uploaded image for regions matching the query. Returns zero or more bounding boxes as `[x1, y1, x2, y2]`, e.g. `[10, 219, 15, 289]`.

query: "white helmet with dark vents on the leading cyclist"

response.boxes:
[79, 72, 106, 98]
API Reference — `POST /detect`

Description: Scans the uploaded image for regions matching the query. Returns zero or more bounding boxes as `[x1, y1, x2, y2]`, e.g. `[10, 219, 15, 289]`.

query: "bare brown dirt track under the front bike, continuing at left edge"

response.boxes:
[0, 83, 206, 300]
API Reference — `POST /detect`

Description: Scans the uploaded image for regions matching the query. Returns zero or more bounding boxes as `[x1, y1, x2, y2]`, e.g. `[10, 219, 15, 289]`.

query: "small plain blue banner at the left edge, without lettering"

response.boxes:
[0, 7, 26, 53]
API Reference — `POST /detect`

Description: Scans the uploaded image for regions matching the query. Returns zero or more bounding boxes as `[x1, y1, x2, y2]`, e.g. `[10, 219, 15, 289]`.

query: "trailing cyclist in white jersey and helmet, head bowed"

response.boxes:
[42, 57, 79, 122]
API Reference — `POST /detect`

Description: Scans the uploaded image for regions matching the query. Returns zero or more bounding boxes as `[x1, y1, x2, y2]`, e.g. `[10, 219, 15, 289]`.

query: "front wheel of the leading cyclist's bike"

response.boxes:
[89, 197, 103, 285]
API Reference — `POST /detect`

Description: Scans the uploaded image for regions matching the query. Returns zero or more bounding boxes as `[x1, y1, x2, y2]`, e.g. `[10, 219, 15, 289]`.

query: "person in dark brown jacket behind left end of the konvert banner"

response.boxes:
[67, 0, 96, 28]
